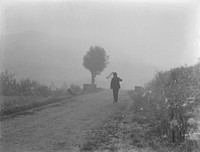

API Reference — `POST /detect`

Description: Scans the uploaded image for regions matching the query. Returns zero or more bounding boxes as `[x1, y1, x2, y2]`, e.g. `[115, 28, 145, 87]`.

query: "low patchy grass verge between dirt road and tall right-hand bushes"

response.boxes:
[81, 91, 200, 152]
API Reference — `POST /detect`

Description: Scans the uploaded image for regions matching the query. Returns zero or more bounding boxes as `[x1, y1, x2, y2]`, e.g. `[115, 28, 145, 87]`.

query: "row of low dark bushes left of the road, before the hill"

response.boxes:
[0, 71, 81, 97]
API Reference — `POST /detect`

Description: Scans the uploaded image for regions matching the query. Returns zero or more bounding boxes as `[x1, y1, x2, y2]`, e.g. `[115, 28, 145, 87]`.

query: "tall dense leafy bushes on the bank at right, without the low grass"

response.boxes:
[131, 63, 200, 152]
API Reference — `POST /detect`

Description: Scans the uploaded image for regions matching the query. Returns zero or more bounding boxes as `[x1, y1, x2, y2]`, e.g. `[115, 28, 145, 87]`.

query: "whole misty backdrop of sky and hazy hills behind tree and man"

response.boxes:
[0, 1, 200, 89]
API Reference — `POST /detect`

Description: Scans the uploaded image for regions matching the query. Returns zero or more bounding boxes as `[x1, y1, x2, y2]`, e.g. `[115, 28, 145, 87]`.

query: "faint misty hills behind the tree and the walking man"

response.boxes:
[0, 31, 155, 88]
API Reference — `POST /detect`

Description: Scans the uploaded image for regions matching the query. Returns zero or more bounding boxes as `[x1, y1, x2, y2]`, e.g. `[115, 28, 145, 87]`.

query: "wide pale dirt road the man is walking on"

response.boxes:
[0, 90, 131, 152]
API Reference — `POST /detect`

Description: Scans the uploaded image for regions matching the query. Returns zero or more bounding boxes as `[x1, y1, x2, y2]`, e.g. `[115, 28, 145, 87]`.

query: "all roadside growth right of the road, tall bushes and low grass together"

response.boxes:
[81, 63, 200, 152]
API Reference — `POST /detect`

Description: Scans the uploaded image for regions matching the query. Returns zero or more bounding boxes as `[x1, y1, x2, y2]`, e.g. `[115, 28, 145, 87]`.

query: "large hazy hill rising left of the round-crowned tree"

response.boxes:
[0, 31, 88, 84]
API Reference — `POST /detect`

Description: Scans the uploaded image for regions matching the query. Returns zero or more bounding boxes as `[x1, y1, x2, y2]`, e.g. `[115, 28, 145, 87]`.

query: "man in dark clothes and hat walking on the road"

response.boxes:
[110, 72, 122, 102]
